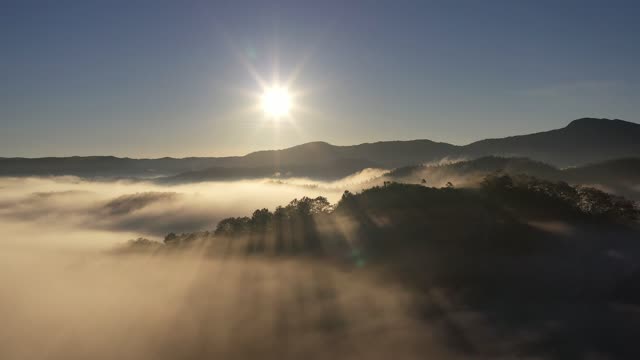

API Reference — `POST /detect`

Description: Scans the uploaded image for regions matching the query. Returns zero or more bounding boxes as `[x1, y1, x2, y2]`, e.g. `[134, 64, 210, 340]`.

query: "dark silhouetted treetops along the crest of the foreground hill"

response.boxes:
[215, 174, 640, 236]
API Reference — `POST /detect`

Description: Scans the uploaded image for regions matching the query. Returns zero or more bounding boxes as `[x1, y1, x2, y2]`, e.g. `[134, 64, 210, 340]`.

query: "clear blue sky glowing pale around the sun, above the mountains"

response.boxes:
[0, 0, 640, 157]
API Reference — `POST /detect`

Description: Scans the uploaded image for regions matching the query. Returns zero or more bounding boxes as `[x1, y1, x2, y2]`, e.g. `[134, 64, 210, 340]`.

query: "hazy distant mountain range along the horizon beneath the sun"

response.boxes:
[0, 118, 640, 181]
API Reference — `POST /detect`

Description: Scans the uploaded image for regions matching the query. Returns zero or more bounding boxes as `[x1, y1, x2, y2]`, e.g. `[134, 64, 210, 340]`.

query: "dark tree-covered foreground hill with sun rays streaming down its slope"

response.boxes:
[129, 176, 640, 359]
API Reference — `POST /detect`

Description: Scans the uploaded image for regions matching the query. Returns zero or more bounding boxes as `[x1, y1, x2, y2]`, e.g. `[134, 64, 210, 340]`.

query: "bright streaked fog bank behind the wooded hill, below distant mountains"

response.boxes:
[0, 174, 381, 247]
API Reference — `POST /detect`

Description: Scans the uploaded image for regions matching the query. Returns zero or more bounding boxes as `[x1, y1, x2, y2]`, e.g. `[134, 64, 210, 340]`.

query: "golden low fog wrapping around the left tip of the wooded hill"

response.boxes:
[0, 171, 470, 359]
